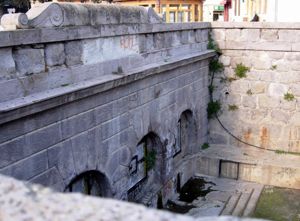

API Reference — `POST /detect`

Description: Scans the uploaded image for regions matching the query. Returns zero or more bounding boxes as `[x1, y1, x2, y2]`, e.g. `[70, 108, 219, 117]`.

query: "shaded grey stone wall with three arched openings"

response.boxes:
[0, 4, 214, 206]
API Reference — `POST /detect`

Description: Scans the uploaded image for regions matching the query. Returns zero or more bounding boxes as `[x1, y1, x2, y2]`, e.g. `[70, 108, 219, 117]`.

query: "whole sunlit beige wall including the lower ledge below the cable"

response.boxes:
[203, 23, 300, 189]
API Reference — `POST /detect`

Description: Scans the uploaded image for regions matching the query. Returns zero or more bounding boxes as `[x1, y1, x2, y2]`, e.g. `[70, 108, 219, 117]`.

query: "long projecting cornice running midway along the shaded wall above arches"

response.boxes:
[0, 51, 215, 124]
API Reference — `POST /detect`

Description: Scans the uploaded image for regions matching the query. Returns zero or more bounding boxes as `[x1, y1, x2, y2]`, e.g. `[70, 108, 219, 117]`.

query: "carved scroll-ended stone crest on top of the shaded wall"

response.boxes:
[1, 3, 162, 29]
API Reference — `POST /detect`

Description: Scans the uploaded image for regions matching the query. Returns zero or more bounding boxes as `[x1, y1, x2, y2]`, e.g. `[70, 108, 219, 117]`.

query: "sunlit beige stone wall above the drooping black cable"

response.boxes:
[210, 23, 300, 153]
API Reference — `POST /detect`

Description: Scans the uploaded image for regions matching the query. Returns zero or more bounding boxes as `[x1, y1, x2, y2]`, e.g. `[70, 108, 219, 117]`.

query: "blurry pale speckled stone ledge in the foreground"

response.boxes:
[0, 175, 266, 221]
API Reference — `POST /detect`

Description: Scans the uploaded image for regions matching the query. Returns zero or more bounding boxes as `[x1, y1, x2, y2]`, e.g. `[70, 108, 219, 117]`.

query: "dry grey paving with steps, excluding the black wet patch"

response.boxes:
[168, 174, 263, 217]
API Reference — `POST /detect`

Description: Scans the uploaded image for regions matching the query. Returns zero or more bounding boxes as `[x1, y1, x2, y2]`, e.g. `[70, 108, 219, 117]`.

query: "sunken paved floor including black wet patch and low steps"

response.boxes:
[164, 175, 262, 217]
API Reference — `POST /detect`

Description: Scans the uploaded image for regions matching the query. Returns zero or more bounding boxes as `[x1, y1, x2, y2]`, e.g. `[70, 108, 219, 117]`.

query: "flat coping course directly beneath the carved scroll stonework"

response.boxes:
[0, 22, 210, 48]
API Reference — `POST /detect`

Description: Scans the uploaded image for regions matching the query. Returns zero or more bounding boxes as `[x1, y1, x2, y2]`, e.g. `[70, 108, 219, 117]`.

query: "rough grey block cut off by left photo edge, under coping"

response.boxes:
[0, 48, 16, 80]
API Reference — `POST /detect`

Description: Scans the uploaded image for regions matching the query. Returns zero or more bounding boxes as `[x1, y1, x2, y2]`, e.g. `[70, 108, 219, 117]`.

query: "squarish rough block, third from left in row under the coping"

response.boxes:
[45, 43, 65, 66]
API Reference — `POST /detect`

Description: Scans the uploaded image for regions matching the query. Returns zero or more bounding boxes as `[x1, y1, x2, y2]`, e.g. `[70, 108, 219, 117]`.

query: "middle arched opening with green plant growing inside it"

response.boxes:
[128, 132, 166, 205]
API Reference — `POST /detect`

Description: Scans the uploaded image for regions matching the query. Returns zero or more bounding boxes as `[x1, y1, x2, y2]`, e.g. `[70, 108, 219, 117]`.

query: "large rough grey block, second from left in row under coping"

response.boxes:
[13, 48, 45, 76]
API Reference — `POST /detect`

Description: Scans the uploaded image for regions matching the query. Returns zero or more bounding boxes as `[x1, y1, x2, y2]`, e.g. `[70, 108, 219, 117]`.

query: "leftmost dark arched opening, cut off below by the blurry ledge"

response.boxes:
[65, 170, 112, 197]
